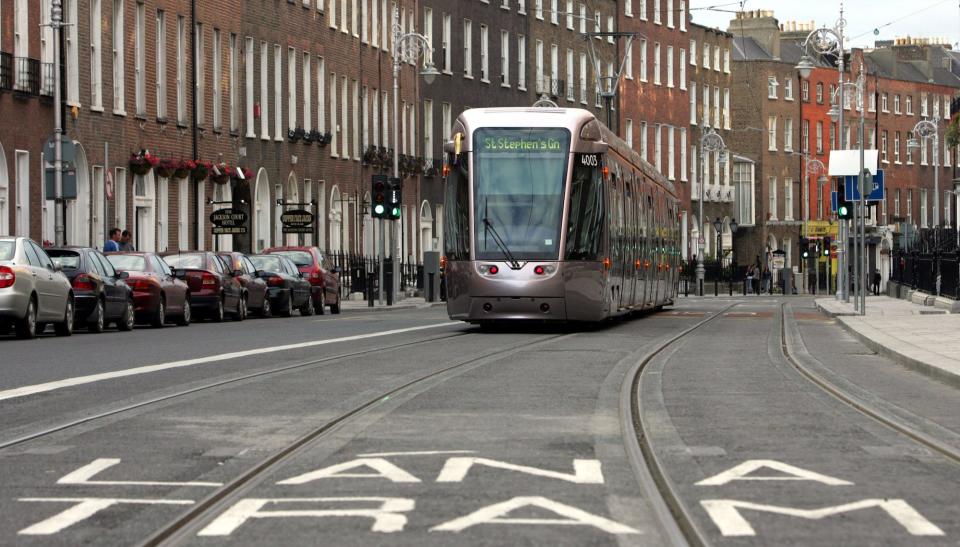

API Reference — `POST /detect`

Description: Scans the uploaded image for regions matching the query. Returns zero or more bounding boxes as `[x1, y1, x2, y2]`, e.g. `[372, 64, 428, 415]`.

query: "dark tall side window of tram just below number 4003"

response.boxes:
[565, 154, 604, 260]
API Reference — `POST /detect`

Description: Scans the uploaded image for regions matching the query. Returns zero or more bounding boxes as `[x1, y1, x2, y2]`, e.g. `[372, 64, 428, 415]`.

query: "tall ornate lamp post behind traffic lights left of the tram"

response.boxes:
[390, 7, 440, 300]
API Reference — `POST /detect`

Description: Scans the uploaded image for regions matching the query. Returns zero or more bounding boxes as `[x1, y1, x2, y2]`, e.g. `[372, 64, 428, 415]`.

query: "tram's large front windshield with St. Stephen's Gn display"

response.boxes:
[473, 128, 570, 260]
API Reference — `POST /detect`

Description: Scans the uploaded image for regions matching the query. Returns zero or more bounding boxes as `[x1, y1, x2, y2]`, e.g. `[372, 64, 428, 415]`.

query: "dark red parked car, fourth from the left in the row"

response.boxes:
[161, 251, 247, 322]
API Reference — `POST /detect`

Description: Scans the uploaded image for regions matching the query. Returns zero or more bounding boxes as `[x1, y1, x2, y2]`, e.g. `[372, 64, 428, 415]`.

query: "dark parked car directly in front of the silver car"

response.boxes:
[46, 247, 133, 332]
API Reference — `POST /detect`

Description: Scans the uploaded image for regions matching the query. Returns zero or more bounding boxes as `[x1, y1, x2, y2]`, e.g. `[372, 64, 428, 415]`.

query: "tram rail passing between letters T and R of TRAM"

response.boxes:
[140, 333, 576, 547]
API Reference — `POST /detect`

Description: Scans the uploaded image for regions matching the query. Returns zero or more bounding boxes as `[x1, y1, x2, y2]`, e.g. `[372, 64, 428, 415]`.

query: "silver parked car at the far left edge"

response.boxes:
[0, 237, 73, 338]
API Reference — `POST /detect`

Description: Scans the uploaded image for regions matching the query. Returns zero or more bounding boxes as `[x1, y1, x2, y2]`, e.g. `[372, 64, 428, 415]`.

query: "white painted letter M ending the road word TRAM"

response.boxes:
[700, 499, 943, 536]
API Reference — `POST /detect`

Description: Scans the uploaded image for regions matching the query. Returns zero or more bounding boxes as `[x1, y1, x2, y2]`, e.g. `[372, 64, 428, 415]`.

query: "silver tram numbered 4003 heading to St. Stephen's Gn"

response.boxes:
[442, 108, 681, 324]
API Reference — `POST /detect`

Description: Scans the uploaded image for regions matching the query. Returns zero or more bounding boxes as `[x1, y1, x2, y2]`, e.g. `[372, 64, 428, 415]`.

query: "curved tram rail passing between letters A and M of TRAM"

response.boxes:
[620, 302, 739, 546]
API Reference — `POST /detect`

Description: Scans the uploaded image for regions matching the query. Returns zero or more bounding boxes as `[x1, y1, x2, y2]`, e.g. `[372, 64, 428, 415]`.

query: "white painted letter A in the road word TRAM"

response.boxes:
[430, 496, 639, 534]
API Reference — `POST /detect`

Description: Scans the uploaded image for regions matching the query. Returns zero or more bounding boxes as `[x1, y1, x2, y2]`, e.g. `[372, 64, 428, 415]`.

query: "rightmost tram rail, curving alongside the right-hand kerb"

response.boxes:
[780, 303, 960, 464]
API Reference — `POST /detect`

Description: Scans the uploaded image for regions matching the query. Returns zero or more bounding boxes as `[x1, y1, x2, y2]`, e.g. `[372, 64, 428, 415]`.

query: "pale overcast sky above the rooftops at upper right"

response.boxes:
[688, 0, 960, 49]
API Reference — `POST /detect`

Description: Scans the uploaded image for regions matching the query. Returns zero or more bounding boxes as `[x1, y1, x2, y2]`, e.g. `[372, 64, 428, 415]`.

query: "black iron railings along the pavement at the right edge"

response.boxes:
[890, 228, 960, 299]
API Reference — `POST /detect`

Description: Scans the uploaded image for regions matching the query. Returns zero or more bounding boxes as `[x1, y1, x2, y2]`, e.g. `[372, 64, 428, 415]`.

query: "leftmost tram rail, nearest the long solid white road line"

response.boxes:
[0, 331, 476, 450]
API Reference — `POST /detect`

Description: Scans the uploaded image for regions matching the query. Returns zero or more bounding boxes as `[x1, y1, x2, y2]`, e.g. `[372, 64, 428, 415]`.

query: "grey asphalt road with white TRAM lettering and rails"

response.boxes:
[0, 298, 960, 545]
